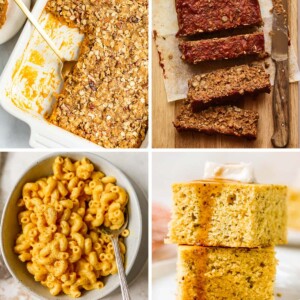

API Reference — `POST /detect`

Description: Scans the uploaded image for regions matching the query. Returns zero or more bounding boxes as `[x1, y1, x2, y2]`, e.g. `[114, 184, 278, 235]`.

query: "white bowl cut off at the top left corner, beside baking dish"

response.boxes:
[0, 0, 31, 45]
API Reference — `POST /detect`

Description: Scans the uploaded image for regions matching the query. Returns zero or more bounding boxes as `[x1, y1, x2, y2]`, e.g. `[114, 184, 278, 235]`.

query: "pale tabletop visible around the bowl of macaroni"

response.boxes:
[0, 153, 148, 300]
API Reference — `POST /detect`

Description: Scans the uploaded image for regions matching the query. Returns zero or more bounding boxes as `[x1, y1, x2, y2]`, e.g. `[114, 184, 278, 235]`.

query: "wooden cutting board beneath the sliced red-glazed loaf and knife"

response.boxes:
[152, 1, 299, 148]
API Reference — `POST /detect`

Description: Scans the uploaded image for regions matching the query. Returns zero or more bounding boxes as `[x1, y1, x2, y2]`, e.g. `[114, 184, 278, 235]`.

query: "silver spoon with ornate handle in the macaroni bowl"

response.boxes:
[100, 210, 131, 300]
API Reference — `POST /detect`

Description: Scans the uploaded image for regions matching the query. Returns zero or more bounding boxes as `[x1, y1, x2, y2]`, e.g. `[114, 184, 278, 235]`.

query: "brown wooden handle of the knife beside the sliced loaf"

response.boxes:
[271, 60, 290, 148]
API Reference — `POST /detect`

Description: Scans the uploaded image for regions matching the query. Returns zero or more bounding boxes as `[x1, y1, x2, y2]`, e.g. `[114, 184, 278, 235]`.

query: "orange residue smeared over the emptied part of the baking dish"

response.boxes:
[6, 12, 83, 116]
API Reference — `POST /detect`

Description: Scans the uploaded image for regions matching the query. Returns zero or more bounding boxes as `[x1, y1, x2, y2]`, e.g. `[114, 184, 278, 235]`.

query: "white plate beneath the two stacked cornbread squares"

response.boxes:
[152, 247, 300, 300]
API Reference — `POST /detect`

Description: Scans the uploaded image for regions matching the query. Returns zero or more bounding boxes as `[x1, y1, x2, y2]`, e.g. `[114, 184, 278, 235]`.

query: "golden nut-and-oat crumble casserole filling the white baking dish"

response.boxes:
[46, 0, 148, 148]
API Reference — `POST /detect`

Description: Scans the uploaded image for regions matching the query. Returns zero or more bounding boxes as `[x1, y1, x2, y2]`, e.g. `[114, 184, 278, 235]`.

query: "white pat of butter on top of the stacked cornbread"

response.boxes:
[203, 161, 255, 183]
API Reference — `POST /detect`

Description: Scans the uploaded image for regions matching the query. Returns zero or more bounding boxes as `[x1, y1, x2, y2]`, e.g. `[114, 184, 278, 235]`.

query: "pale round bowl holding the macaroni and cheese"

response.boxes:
[1, 152, 142, 300]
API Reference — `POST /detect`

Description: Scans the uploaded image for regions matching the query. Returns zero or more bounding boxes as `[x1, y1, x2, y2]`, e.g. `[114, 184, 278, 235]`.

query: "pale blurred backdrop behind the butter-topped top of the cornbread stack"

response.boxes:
[152, 151, 300, 207]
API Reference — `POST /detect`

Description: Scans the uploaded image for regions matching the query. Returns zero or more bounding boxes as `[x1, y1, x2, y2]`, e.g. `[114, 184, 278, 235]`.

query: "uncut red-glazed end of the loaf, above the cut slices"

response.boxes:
[176, 0, 263, 36]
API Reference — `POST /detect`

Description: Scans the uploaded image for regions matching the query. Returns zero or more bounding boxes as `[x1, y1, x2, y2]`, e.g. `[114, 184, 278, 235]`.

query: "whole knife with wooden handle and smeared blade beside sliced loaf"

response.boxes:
[271, 0, 290, 148]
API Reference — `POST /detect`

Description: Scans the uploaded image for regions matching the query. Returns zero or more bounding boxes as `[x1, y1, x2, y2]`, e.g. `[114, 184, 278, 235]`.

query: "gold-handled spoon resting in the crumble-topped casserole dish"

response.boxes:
[14, 0, 77, 79]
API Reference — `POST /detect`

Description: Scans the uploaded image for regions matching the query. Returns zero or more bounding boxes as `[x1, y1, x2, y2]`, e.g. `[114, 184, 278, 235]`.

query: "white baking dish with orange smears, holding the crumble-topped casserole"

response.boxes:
[0, 0, 148, 149]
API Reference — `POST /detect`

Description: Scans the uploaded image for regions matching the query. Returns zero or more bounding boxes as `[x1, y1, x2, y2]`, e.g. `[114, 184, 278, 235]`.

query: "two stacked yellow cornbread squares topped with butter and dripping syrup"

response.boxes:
[166, 164, 287, 300]
